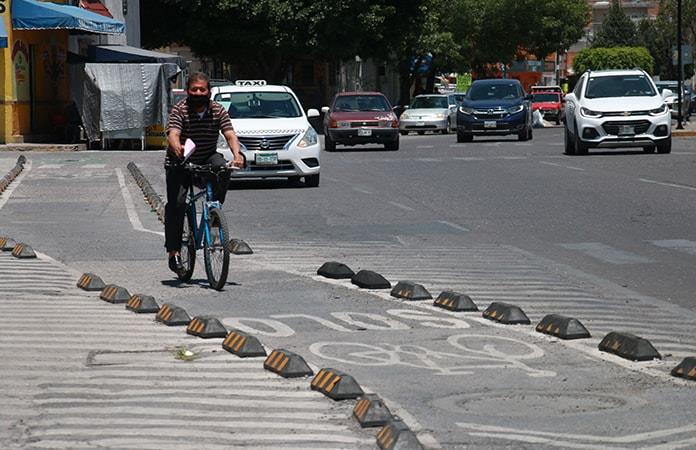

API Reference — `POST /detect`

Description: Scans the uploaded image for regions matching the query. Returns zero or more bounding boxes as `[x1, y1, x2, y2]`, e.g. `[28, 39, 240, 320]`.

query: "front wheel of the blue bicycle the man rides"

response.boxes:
[203, 208, 230, 291]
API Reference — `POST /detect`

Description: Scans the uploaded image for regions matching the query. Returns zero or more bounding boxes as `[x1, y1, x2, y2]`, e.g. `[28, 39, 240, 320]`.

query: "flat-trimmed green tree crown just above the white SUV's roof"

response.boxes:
[573, 47, 655, 74]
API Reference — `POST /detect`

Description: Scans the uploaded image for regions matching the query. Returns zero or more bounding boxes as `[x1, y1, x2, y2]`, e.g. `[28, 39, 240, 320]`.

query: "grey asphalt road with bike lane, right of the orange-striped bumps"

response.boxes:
[0, 128, 696, 448]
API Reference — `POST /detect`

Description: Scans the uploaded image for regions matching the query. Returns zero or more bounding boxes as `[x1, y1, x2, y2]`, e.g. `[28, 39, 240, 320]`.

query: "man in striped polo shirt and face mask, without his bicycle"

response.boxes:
[164, 72, 244, 274]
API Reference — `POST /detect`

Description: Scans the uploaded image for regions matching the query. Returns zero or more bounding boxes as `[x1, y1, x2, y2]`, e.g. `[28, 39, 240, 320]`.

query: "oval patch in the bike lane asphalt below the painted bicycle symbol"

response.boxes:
[434, 391, 629, 417]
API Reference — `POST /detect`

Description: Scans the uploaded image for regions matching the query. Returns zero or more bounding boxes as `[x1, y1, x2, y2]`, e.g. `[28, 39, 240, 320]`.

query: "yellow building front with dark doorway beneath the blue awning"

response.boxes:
[0, 2, 70, 143]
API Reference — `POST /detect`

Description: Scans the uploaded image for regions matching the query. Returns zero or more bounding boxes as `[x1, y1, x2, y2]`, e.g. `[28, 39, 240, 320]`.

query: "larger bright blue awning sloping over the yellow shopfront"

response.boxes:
[12, 0, 126, 34]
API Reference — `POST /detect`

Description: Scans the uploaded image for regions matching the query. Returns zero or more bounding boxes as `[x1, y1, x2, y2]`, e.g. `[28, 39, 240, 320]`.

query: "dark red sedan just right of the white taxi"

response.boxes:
[321, 92, 399, 152]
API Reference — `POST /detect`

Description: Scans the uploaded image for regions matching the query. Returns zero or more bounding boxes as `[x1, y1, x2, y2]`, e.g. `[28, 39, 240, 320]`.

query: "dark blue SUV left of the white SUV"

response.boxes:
[457, 79, 532, 142]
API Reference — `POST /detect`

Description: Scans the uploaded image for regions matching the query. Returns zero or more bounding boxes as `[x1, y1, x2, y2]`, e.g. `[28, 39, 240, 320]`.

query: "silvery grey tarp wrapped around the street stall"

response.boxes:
[70, 63, 180, 141]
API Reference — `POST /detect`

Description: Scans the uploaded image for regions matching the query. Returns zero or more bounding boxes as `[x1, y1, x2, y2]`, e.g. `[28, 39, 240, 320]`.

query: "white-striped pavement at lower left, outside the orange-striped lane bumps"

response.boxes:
[0, 252, 376, 449]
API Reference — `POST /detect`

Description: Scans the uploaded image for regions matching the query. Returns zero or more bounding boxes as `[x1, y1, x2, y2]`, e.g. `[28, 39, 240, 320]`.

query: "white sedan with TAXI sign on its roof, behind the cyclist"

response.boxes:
[211, 80, 321, 187]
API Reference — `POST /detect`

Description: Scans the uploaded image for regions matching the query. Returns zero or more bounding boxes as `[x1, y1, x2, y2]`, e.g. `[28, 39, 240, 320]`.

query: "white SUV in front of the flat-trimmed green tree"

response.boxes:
[565, 70, 672, 155]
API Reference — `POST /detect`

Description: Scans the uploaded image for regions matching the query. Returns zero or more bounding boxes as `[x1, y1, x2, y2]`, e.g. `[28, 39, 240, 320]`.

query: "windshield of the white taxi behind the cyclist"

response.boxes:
[213, 92, 302, 119]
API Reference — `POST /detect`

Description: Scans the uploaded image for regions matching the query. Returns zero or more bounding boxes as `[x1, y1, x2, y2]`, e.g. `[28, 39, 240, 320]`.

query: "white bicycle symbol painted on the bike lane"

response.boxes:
[309, 334, 556, 377]
